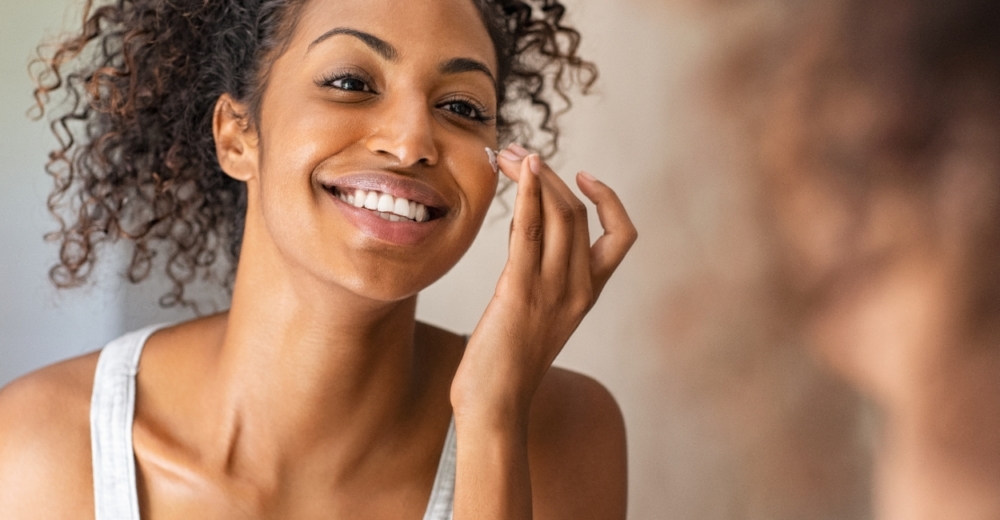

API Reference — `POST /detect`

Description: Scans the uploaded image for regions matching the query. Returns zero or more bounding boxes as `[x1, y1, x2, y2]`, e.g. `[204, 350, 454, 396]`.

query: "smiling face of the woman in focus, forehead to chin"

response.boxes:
[238, 0, 497, 301]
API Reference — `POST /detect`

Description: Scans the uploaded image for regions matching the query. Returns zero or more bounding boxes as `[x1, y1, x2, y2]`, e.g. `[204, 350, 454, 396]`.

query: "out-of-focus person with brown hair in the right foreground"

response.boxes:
[744, 0, 1000, 519]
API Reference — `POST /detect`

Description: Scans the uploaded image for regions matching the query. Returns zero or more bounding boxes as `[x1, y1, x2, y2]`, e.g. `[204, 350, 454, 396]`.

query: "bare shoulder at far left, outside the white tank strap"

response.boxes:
[0, 353, 98, 520]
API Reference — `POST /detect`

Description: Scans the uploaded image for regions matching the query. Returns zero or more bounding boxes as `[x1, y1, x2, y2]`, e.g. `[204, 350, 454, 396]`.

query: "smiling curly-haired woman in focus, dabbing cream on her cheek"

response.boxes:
[0, 0, 636, 519]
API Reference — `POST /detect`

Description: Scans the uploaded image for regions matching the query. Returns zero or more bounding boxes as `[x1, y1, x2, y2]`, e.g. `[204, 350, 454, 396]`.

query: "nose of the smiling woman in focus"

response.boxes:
[367, 94, 438, 167]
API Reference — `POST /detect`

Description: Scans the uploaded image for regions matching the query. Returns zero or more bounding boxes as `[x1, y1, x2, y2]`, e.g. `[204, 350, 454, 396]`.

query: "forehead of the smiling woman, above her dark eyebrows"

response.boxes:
[289, 0, 497, 73]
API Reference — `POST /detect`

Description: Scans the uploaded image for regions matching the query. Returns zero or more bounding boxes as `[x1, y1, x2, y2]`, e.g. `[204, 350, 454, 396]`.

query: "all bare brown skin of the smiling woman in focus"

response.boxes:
[0, 0, 636, 520]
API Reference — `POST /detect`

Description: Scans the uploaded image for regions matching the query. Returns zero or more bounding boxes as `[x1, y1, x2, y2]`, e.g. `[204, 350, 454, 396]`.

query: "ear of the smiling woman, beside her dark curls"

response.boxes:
[212, 94, 259, 182]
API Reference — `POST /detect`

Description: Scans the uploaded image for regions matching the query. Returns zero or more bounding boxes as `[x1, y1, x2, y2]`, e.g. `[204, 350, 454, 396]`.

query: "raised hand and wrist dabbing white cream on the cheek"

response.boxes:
[451, 145, 636, 427]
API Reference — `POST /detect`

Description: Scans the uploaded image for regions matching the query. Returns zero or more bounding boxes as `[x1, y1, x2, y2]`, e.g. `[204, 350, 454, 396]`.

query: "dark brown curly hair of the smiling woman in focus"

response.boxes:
[32, 0, 597, 310]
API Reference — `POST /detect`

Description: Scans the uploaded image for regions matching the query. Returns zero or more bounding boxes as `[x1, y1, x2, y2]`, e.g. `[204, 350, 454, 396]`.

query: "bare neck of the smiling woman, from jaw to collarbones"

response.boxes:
[203, 232, 427, 476]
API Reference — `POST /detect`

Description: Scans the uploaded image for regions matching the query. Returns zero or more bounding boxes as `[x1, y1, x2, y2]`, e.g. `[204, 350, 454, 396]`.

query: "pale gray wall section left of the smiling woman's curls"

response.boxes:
[0, 0, 121, 384]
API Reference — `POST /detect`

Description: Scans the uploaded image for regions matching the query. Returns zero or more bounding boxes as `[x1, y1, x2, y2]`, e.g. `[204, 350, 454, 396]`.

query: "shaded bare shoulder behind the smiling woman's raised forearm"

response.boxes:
[528, 367, 628, 520]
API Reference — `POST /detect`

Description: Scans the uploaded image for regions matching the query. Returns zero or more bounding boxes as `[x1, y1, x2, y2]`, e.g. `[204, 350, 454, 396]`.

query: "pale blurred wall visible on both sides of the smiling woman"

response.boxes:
[0, 0, 874, 520]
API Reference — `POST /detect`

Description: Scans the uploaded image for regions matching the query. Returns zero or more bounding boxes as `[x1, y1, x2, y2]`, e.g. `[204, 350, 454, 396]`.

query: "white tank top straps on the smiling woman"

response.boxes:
[90, 325, 455, 520]
